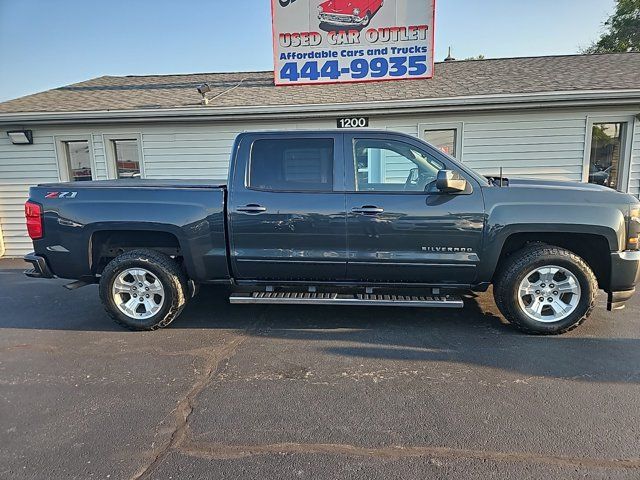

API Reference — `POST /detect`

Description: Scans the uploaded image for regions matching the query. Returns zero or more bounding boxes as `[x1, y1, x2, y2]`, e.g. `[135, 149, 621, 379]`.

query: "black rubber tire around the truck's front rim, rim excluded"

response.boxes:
[493, 244, 598, 335]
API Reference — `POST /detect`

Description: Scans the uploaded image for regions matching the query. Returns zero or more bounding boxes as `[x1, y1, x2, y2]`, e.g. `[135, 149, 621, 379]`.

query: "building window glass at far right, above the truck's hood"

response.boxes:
[589, 122, 626, 189]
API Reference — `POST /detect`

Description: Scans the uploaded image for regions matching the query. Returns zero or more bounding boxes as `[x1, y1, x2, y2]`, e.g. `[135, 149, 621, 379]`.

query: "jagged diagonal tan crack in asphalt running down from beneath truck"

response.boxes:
[131, 315, 263, 480]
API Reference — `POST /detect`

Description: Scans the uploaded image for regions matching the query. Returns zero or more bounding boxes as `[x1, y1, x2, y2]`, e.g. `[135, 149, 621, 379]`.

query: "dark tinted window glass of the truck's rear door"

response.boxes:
[248, 138, 333, 192]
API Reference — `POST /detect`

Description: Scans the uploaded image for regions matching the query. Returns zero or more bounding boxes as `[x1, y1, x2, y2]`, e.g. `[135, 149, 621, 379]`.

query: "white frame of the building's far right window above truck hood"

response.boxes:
[582, 115, 636, 192]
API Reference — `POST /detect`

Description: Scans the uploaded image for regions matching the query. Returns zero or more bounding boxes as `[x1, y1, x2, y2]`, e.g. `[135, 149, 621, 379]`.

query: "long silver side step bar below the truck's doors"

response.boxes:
[229, 292, 464, 308]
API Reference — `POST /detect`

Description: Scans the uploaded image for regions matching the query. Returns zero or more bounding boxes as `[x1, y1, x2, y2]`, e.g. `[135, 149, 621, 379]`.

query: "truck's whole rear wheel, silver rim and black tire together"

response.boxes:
[100, 249, 188, 330]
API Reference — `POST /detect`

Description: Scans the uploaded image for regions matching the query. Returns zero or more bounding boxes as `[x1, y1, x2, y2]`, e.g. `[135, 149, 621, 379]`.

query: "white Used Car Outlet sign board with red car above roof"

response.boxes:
[271, 0, 435, 85]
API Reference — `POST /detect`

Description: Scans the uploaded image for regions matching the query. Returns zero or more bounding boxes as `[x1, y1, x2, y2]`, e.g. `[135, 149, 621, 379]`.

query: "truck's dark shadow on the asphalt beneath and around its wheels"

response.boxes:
[0, 276, 640, 383]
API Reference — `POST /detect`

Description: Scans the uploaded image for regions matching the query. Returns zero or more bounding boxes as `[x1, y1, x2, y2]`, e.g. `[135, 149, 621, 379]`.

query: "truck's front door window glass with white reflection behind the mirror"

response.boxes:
[353, 139, 444, 192]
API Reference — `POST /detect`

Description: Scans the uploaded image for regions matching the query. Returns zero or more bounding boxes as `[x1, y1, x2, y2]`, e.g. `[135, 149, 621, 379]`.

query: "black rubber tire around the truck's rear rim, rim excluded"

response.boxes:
[100, 249, 189, 330]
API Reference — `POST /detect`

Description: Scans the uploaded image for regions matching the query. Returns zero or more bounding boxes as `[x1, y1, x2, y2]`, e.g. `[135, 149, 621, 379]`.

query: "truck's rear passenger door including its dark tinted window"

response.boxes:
[228, 132, 347, 281]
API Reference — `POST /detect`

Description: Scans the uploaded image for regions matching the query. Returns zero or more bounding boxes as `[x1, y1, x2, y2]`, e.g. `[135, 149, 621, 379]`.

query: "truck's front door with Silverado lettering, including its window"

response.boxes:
[344, 133, 484, 284]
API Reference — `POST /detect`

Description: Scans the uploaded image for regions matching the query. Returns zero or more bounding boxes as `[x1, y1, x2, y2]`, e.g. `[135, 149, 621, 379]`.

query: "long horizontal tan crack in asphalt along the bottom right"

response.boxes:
[176, 442, 640, 470]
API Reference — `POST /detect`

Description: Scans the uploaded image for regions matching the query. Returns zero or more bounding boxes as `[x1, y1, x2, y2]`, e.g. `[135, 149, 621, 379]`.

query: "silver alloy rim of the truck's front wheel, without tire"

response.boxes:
[518, 265, 580, 323]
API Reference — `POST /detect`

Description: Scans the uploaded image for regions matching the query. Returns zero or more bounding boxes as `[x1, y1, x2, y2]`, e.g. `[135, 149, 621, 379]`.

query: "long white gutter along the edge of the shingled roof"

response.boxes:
[0, 89, 640, 125]
